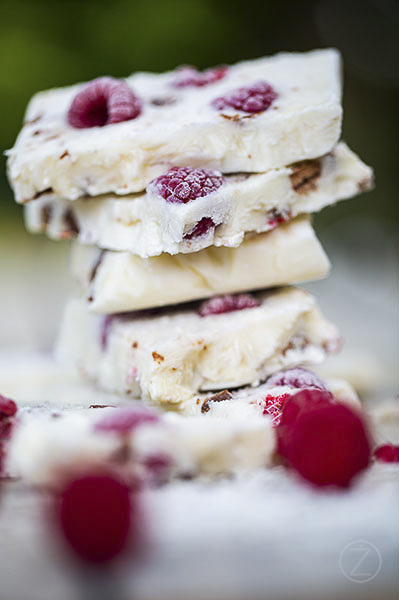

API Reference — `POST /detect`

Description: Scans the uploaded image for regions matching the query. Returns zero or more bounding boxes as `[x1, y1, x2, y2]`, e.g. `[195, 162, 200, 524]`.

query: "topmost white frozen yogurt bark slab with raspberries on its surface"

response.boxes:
[8, 49, 342, 202]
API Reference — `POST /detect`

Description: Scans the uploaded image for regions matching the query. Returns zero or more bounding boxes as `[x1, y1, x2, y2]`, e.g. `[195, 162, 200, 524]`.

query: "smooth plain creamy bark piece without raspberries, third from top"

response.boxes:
[70, 217, 329, 313]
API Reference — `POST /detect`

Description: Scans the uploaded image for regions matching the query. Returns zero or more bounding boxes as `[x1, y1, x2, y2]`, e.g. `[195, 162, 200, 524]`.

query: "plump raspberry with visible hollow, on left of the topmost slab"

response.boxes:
[68, 77, 141, 129]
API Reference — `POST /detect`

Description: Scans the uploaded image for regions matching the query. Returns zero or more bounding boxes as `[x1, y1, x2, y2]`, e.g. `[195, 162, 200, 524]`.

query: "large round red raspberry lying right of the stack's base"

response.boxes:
[276, 390, 371, 487]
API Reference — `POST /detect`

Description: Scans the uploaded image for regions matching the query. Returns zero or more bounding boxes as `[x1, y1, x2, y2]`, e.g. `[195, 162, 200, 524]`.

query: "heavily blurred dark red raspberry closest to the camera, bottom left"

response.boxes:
[55, 473, 137, 563]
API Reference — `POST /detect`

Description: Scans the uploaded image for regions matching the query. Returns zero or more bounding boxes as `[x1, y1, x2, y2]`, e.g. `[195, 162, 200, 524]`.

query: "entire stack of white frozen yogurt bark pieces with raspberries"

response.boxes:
[4, 50, 372, 480]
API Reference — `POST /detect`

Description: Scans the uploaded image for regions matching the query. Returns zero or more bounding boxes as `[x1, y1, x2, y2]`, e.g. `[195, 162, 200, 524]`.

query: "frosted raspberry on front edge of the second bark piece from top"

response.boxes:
[148, 167, 224, 204]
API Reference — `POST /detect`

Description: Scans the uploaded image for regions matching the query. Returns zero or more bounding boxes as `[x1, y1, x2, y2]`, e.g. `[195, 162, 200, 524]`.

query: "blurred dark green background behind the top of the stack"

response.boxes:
[0, 0, 399, 233]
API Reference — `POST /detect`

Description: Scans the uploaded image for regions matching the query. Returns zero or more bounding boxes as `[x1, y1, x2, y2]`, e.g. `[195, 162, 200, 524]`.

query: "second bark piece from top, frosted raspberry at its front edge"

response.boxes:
[25, 142, 372, 258]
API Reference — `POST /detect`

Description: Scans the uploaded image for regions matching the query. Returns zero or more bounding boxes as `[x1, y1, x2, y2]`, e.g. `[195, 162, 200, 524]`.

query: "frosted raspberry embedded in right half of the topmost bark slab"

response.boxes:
[212, 81, 277, 113]
